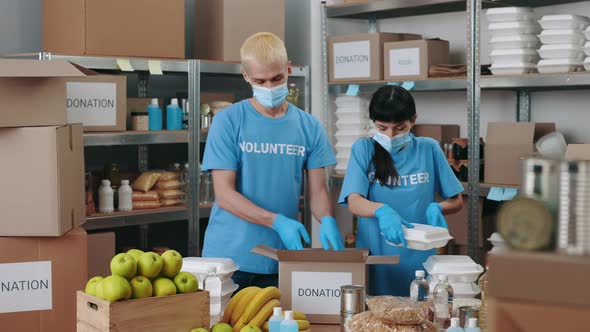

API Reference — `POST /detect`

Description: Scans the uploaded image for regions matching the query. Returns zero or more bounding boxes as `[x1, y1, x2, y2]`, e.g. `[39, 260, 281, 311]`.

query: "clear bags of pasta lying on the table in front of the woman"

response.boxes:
[348, 296, 437, 332]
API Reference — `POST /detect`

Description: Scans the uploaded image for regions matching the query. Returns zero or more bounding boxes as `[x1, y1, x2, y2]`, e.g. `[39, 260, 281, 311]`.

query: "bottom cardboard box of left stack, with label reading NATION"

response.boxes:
[0, 228, 88, 332]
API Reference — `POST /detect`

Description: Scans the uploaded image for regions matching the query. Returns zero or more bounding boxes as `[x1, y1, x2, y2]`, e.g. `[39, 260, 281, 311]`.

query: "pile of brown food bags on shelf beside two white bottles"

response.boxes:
[131, 171, 185, 210]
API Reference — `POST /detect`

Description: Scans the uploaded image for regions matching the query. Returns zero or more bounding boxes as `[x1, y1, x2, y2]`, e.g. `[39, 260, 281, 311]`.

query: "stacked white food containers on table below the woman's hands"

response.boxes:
[422, 255, 483, 298]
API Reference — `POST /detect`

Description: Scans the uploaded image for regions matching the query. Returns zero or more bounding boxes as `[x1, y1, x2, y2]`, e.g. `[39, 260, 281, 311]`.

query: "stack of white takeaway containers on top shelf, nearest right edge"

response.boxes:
[538, 15, 590, 73]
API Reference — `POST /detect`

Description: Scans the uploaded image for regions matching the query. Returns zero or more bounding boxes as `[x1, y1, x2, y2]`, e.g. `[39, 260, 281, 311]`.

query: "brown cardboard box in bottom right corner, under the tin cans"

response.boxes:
[488, 252, 590, 332]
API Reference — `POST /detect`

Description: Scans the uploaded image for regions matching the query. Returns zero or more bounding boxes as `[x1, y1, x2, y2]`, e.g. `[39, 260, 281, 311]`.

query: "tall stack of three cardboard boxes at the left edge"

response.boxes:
[0, 60, 117, 332]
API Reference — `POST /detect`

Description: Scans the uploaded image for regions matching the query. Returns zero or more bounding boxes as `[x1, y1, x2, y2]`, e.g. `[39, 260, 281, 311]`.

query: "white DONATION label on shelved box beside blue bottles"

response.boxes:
[66, 82, 117, 126]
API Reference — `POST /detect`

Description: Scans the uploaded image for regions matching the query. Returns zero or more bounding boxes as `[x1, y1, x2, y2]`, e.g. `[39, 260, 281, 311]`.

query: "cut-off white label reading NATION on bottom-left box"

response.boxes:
[0, 261, 52, 313]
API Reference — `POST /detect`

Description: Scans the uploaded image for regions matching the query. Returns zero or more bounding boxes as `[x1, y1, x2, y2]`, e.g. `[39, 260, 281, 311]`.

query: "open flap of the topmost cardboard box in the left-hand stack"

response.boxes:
[0, 59, 86, 77]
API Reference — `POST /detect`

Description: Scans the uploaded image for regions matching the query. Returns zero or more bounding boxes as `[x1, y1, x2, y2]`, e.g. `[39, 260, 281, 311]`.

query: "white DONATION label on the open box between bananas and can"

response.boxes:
[291, 272, 352, 315]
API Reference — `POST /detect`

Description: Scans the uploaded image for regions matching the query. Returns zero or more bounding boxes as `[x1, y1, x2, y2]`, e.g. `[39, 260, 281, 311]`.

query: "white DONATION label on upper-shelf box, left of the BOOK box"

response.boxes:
[332, 40, 371, 79]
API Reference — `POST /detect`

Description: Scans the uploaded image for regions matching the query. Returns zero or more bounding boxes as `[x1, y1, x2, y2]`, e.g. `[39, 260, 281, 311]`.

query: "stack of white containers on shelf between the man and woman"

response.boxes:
[334, 96, 369, 174]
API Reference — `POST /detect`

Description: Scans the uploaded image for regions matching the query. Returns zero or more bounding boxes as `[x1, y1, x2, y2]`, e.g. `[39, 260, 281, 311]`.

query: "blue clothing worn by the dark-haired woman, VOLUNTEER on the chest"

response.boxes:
[339, 135, 463, 296]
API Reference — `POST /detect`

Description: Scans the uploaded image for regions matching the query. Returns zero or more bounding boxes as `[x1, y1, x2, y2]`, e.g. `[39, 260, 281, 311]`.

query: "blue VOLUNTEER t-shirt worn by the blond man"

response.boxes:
[202, 100, 336, 274]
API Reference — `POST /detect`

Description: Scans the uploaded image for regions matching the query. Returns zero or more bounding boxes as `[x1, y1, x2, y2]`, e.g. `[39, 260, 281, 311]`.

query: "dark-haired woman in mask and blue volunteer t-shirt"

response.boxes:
[339, 85, 463, 296]
